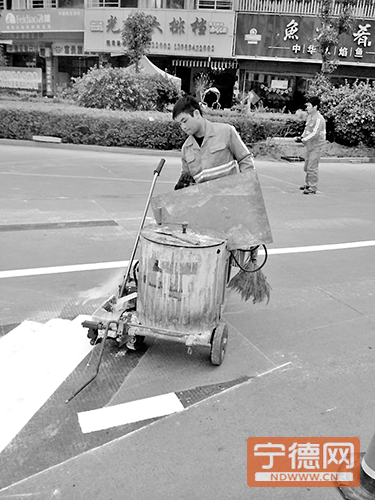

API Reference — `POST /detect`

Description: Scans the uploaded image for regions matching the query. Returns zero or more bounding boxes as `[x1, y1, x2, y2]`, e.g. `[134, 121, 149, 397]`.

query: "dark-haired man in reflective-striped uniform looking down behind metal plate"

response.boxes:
[172, 96, 257, 272]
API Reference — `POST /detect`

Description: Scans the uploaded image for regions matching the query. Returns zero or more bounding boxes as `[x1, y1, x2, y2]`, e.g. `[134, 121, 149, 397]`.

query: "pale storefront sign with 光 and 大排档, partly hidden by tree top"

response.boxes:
[85, 9, 234, 57]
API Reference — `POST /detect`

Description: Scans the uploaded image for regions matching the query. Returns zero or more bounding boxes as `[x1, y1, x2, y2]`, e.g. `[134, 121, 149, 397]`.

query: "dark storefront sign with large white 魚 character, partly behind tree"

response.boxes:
[235, 14, 375, 65]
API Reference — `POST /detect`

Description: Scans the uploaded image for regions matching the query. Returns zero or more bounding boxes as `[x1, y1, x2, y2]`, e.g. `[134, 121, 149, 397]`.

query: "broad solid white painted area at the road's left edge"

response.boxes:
[0, 315, 92, 452]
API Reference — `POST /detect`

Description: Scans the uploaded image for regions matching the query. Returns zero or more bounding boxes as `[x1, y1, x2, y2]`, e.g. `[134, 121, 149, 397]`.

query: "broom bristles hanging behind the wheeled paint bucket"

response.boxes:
[228, 259, 271, 304]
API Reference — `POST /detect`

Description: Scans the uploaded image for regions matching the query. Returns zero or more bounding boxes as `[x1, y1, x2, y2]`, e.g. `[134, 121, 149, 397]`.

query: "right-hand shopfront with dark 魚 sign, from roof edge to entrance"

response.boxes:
[234, 0, 375, 111]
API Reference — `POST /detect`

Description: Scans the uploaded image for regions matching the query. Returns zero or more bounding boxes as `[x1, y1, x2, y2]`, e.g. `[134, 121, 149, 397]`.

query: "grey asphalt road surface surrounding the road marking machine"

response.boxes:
[0, 144, 375, 500]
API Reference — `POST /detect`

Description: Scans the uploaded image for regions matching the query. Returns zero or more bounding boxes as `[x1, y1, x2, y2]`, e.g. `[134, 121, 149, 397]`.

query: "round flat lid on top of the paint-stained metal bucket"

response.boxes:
[141, 224, 226, 248]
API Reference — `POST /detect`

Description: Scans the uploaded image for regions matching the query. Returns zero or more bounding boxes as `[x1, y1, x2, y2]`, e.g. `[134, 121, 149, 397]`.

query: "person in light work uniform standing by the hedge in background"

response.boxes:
[296, 96, 326, 194]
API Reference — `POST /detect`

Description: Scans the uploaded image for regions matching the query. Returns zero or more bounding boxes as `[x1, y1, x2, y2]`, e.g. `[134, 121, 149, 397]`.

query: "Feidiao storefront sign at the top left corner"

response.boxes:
[0, 9, 83, 33]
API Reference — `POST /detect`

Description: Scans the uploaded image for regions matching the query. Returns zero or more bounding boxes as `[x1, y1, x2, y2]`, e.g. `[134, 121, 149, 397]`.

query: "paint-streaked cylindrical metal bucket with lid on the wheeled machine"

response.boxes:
[137, 225, 228, 333]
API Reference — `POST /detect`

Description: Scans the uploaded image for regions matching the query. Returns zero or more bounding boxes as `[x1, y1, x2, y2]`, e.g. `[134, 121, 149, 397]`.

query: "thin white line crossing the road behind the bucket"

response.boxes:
[0, 240, 375, 279]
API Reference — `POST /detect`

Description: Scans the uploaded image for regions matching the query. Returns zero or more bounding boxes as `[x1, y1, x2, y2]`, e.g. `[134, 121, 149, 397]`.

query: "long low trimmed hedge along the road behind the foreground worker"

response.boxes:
[0, 101, 304, 150]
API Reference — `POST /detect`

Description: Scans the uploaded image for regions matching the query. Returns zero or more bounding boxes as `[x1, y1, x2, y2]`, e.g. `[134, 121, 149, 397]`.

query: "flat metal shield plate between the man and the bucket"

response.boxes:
[151, 170, 272, 250]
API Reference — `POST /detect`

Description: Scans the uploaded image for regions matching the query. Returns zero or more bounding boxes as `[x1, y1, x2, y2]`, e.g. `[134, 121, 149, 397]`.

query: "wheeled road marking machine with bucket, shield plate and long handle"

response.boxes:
[66, 159, 272, 402]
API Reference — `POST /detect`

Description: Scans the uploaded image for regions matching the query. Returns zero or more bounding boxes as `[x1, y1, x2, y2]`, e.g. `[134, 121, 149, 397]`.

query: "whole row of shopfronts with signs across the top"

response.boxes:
[0, 0, 375, 110]
